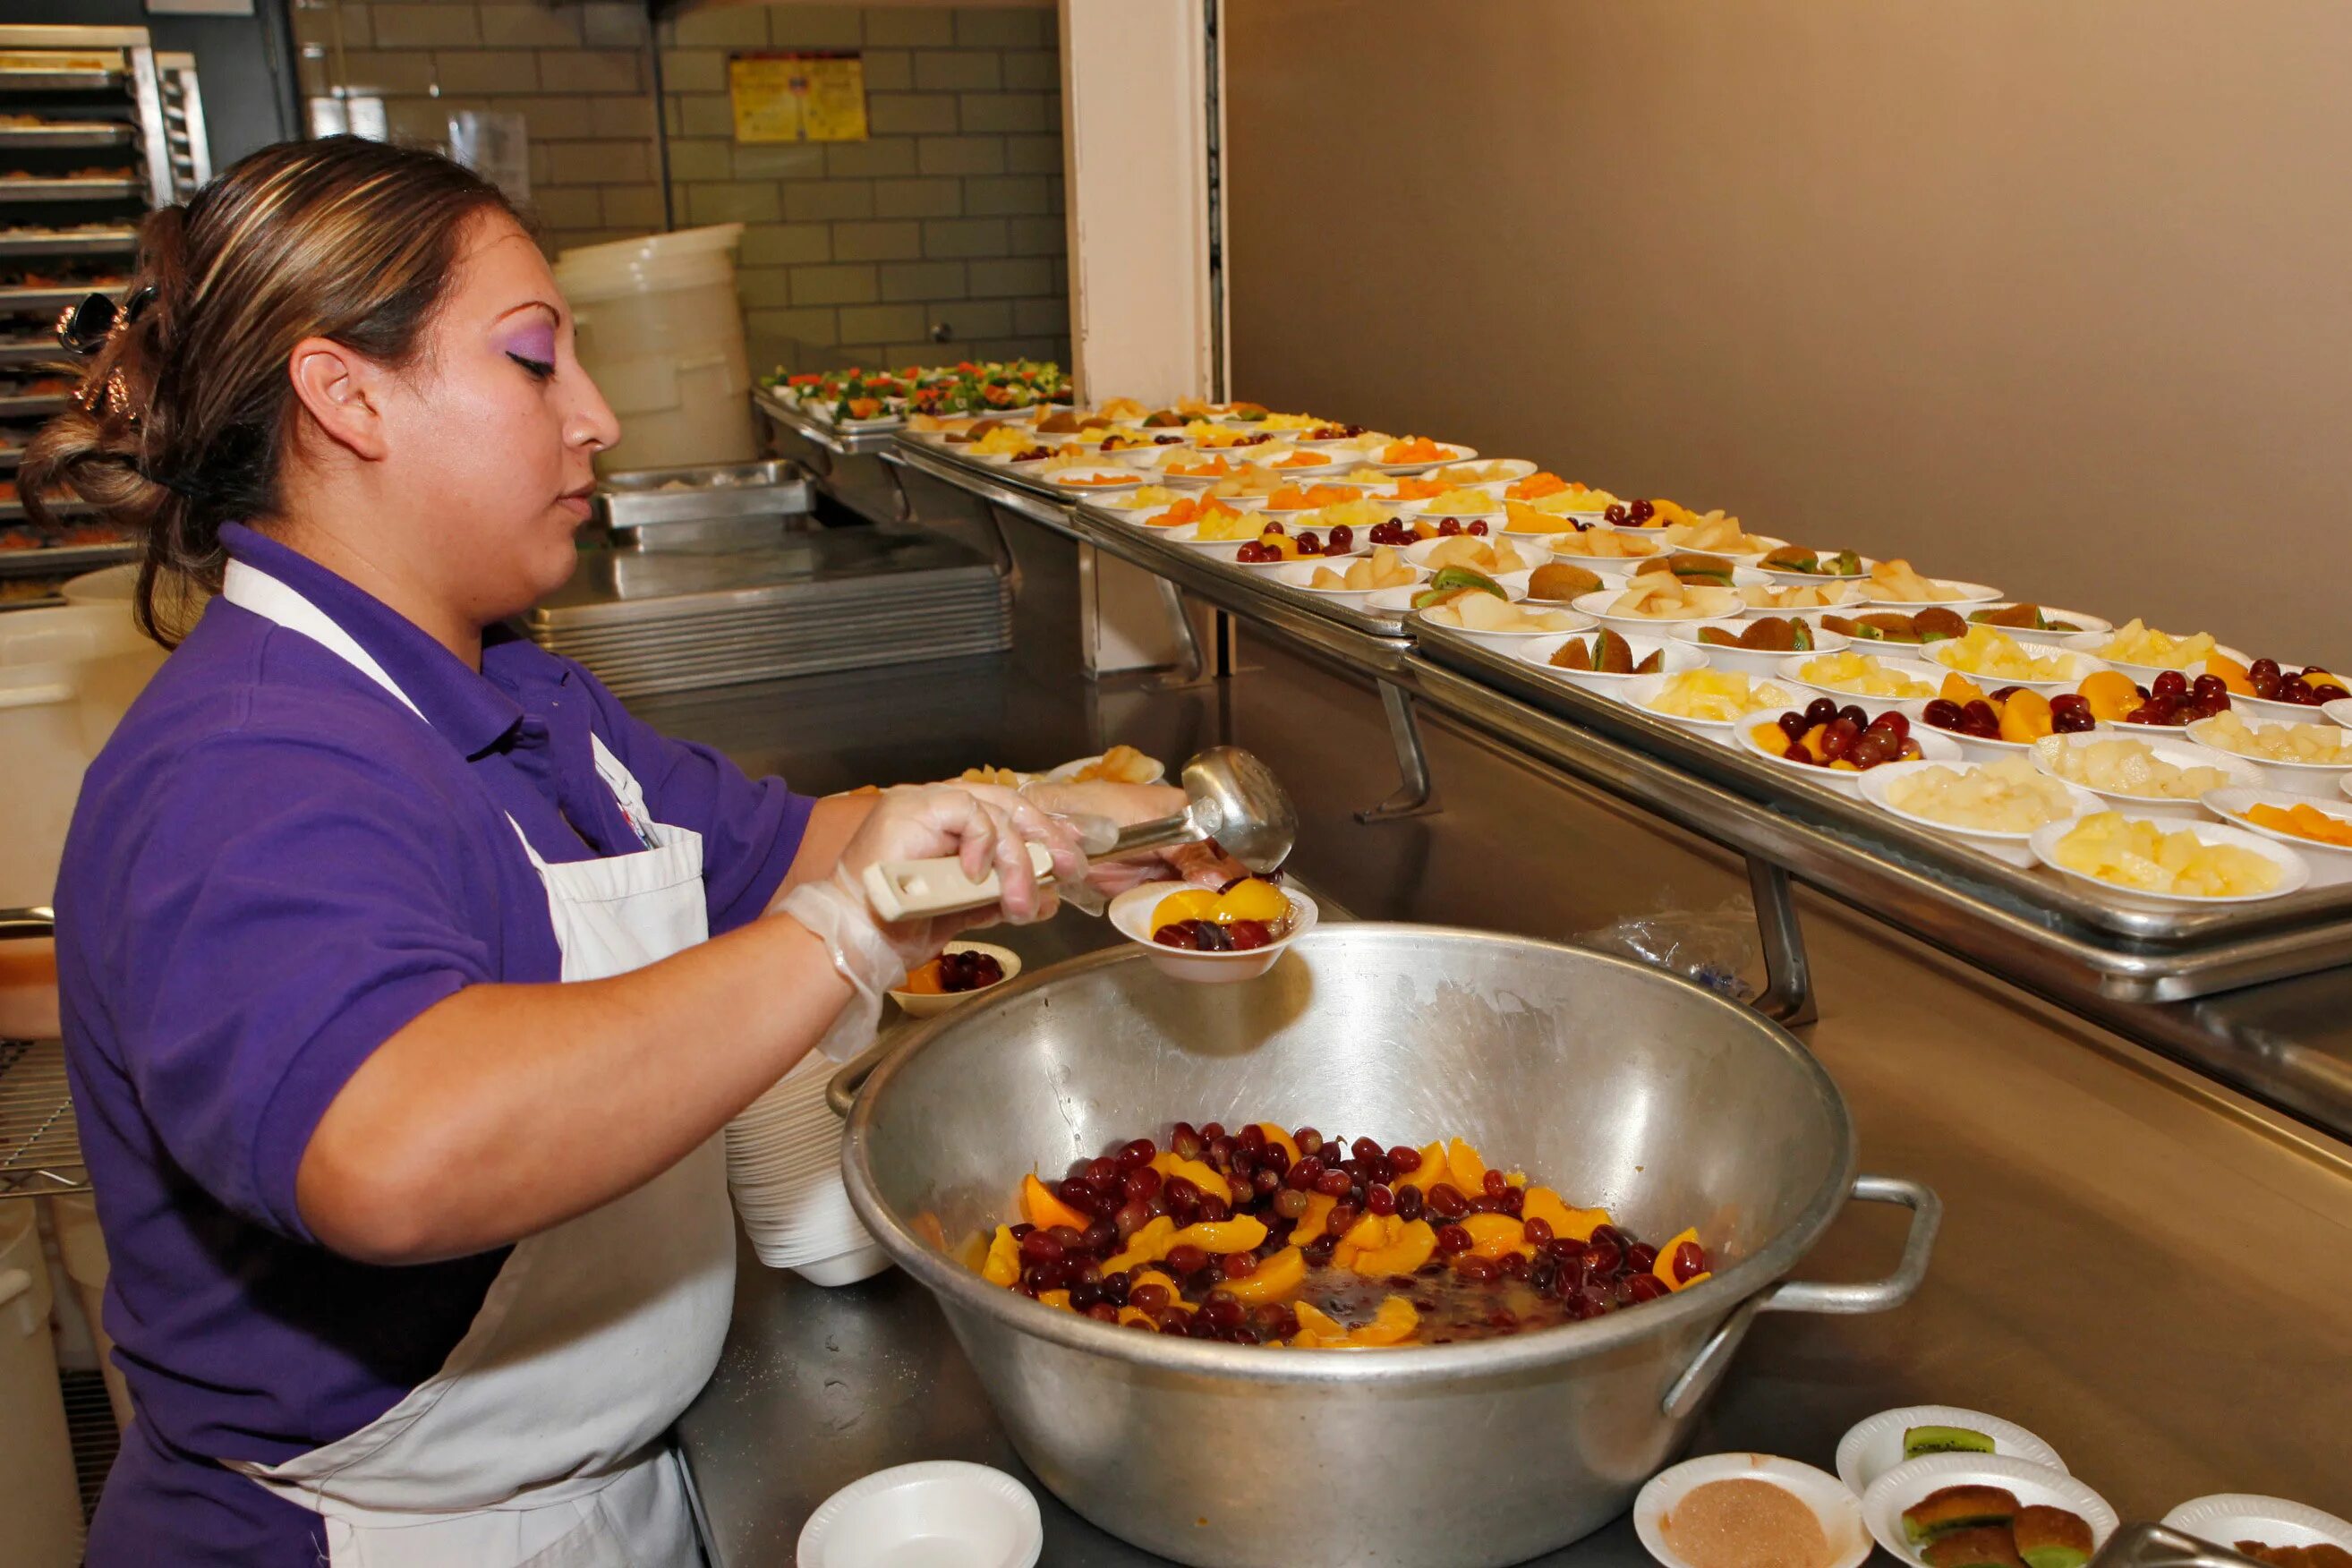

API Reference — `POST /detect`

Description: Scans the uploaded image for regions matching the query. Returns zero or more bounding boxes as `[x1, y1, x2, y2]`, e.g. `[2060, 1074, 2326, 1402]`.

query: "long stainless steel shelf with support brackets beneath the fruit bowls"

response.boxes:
[860, 430, 2352, 1133]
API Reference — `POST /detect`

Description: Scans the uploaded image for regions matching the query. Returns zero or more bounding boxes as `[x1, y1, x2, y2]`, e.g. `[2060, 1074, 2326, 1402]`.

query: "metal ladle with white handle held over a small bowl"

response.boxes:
[865, 746, 1299, 922]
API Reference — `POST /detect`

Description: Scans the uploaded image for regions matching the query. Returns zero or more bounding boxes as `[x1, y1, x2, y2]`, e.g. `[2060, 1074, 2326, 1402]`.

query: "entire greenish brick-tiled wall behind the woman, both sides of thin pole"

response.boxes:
[294, 0, 1070, 369]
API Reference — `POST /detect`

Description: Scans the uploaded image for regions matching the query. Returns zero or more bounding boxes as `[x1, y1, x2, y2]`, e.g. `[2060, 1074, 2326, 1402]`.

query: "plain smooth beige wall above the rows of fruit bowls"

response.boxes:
[1225, 0, 2352, 660]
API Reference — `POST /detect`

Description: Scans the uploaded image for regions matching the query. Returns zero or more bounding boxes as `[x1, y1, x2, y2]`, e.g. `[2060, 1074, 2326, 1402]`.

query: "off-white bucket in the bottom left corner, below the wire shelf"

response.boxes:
[0, 1199, 82, 1568]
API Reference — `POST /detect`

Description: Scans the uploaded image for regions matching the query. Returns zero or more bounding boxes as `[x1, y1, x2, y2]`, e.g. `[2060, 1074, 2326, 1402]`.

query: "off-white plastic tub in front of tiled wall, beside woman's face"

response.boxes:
[555, 224, 760, 473]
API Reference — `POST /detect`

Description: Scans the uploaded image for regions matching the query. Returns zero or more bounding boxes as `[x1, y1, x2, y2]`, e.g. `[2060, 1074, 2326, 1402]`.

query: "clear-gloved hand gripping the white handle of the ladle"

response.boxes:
[776, 785, 1085, 1061]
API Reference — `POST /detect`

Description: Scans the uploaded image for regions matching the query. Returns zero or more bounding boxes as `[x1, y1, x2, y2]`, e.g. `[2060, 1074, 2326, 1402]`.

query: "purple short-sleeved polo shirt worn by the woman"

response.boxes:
[56, 526, 814, 1568]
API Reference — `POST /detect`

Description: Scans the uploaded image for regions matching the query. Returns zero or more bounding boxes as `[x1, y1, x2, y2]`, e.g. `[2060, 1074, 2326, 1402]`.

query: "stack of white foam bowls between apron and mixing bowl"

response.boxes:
[727, 1051, 889, 1286]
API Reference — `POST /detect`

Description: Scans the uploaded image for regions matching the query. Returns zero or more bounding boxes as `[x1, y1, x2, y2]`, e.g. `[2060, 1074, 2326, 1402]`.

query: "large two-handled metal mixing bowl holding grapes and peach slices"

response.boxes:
[842, 924, 1938, 1568]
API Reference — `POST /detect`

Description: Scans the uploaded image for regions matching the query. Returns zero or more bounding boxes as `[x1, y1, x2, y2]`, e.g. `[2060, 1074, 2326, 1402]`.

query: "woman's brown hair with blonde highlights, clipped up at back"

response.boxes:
[19, 136, 516, 646]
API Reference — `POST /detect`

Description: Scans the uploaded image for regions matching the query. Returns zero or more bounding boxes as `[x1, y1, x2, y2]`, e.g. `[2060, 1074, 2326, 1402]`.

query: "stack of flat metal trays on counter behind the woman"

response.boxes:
[524, 526, 1011, 695]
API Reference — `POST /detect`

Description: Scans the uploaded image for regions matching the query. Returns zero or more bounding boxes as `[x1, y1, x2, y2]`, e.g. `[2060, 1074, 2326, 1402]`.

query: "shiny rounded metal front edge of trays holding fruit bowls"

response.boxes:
[884, 422, 2352, 1001]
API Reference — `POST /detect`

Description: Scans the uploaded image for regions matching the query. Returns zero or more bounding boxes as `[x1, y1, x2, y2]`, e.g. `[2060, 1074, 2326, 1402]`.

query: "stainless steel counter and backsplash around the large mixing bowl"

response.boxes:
[640, 536, 2352, 1568]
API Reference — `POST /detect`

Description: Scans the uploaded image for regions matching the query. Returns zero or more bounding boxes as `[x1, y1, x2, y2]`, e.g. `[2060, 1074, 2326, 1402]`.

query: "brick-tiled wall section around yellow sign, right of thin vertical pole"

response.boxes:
[660, 4, 1070, 369]
